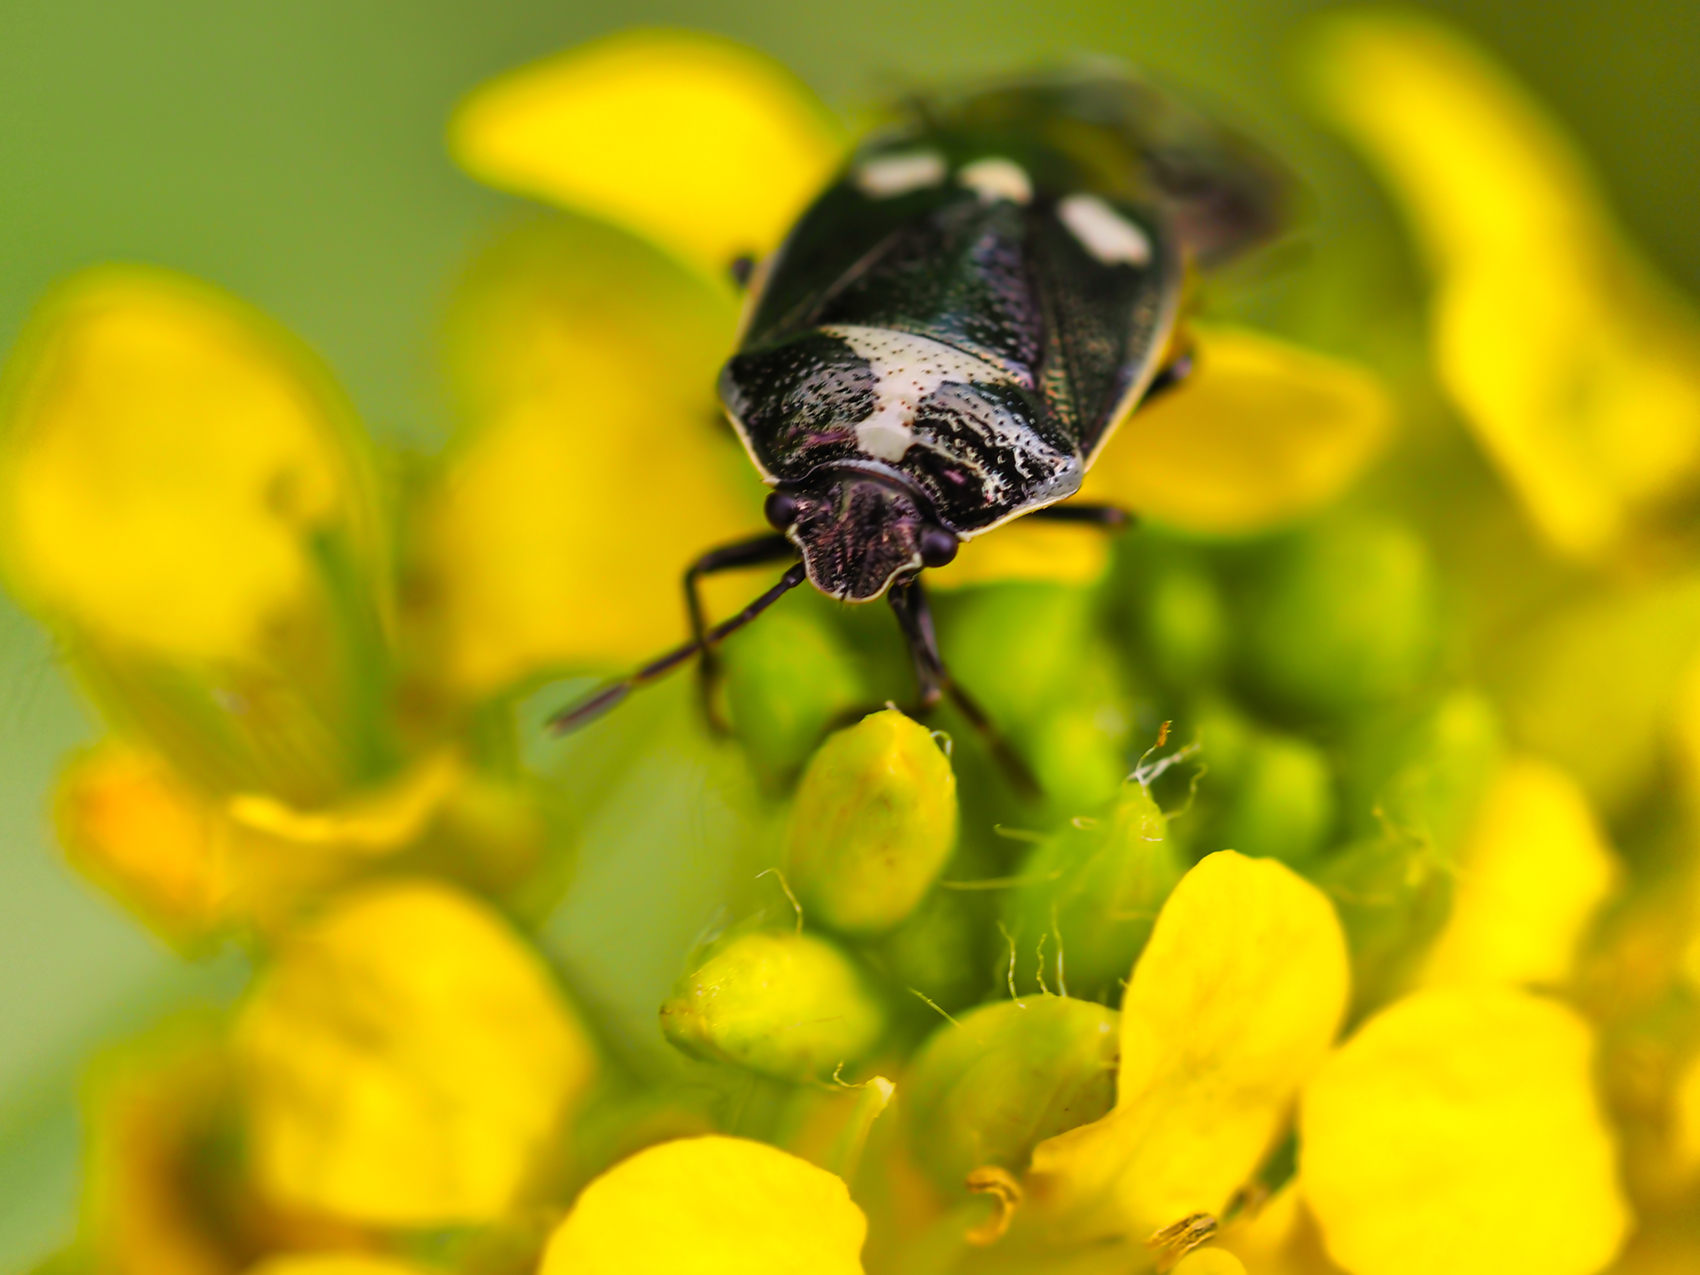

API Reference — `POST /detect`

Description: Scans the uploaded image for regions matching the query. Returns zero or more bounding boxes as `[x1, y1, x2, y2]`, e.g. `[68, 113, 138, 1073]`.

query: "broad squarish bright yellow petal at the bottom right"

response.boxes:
[1299, 988, 1630, 1275]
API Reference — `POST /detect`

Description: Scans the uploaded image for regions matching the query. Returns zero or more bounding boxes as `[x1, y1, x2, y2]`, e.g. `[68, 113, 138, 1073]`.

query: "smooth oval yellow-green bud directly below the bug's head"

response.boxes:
[785, 709, 957, 933]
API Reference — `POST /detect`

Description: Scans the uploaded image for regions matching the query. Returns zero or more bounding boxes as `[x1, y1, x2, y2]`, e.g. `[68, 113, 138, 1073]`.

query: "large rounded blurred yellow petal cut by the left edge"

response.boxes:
[0, 267, 376, 663]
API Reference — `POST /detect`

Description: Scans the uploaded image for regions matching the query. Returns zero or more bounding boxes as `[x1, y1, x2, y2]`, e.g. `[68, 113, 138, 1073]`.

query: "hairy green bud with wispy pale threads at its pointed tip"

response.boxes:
[1005, 779, 1183, 1000]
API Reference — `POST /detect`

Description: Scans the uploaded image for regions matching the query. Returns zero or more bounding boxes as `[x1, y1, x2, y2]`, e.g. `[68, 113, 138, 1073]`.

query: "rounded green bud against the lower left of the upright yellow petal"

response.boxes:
[903, 996, 1120, 1192]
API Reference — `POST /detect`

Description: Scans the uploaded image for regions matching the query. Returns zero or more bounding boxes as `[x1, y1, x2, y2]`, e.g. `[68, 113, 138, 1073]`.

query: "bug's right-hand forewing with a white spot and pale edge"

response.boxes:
[1029, 196, 1182, 462]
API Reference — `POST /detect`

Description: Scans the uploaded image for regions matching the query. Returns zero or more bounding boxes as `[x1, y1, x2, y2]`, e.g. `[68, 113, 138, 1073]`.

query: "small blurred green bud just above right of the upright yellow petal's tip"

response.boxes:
[1209, 731, 1338, 864]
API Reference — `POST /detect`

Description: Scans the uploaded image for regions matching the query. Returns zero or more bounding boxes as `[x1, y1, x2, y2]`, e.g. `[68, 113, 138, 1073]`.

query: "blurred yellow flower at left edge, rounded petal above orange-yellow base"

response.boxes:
[0, 267, 564, 947]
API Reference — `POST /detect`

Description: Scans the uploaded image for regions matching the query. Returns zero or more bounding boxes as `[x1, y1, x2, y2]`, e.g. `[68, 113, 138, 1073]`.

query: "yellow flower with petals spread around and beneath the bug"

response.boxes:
[418, 32, 1391, 692]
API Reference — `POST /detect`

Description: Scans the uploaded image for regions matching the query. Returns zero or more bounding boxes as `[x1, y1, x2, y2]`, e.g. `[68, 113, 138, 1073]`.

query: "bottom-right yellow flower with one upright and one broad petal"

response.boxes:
[1029, 852, 1629, 1275]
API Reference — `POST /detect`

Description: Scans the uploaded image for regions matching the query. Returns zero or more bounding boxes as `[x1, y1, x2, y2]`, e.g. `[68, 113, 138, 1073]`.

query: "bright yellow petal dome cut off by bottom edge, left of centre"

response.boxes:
[539, 1137, 867, 1275]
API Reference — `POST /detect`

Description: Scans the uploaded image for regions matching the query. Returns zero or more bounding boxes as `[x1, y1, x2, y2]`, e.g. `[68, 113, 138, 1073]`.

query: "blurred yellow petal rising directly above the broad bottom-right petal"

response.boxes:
[1425, 758, 1618, 986]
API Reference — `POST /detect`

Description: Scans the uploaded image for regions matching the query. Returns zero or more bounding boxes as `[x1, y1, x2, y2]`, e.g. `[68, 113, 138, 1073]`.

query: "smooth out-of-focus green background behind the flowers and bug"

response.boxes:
[0, 0, 1700, 1268]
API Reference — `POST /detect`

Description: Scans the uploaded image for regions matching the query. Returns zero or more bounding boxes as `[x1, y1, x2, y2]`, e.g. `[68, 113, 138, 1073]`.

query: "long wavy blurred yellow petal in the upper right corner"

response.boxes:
[1314, 14, 1700, 558]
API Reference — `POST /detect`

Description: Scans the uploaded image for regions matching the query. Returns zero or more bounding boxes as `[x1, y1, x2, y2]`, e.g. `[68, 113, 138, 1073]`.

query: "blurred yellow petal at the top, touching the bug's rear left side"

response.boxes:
[449, 31, 845, 279]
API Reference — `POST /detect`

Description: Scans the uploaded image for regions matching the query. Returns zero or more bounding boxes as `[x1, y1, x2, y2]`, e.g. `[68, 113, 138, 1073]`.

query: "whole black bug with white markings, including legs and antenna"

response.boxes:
[554, 66, 1285, 788]
